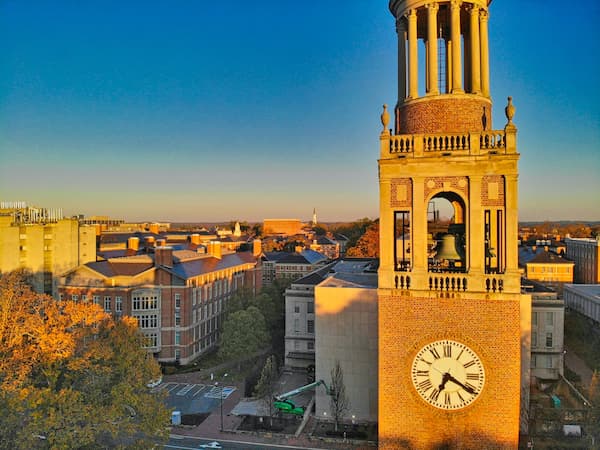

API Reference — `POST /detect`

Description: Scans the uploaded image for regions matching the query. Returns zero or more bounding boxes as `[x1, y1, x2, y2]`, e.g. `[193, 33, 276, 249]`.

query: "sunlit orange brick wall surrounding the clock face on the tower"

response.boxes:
[379, 291, 521, 449]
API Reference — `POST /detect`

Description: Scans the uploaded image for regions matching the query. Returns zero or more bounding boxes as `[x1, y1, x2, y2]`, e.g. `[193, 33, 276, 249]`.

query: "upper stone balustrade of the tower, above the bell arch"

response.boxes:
[381, 129, 516, 158]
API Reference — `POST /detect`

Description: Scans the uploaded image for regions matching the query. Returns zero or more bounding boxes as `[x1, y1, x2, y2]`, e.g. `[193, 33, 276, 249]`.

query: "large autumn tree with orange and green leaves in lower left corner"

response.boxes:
[0, 271, 169, 449]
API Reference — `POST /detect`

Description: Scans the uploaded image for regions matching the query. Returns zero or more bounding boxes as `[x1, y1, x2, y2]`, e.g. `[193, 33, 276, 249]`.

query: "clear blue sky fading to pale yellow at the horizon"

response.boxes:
[0, 0, 600, 221]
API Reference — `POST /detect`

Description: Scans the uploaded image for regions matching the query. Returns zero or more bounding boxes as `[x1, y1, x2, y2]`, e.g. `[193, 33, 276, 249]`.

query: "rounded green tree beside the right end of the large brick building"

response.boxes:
[219, 306, 270, 369]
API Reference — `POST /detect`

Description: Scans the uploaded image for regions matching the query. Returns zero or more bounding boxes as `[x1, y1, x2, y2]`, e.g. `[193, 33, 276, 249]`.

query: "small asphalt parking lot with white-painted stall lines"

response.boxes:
[152, 382, 236, 414]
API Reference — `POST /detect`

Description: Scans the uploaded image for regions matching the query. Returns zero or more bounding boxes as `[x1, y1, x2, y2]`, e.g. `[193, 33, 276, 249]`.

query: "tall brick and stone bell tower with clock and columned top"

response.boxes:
[378, 0, 530, 449]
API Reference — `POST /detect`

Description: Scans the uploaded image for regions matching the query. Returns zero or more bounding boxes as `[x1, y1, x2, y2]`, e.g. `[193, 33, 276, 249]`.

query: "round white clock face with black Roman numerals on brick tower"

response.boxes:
[411, 340, 485, 410]
